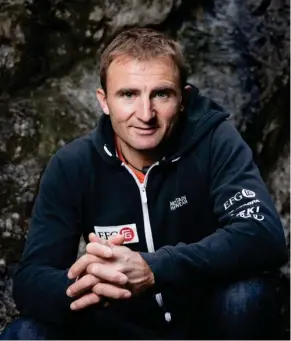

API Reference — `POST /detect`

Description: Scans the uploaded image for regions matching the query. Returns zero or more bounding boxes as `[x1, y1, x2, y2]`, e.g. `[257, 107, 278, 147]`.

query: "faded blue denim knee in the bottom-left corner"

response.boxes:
[1, 317, 48, 340]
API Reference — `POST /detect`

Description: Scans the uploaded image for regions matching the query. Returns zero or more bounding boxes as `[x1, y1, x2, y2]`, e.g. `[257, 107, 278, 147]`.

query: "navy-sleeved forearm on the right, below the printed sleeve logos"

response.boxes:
[141, 223, 287, 291]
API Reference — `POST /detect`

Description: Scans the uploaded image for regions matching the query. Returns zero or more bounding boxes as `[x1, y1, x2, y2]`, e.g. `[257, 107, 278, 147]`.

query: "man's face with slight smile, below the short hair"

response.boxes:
[97, 56, 182, 151]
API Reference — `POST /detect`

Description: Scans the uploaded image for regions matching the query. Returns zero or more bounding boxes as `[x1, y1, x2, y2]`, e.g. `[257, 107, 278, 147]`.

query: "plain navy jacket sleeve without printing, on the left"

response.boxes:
[13, 149, 81, 323]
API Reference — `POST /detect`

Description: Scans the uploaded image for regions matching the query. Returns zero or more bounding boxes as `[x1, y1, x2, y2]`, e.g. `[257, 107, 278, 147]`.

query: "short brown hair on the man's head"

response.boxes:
[100, 28, 187, 92]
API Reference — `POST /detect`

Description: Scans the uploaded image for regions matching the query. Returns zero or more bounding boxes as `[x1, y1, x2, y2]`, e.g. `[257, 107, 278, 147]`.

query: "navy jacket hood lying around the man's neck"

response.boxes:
[91, 84, 230, 165]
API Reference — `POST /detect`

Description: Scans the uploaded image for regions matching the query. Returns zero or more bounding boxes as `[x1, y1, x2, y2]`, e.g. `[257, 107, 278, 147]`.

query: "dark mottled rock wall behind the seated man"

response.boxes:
[0, 0, 290, 339]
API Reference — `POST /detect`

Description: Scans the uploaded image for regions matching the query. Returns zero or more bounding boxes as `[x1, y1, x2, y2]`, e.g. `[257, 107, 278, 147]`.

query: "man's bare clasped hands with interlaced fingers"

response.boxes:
[67, 233, 154, 310]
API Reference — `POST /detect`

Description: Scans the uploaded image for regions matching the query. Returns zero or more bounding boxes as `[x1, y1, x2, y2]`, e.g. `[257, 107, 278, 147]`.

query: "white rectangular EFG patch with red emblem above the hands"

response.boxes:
[94, 224, 139, 244]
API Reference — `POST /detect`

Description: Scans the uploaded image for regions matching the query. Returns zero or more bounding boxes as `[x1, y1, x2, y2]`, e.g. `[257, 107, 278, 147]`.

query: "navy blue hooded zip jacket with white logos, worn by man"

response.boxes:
[14, 87, 287, 323]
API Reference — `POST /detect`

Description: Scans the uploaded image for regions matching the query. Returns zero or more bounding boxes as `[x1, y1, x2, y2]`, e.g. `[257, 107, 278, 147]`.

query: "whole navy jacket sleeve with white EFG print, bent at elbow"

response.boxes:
[141, 121, 287, 290]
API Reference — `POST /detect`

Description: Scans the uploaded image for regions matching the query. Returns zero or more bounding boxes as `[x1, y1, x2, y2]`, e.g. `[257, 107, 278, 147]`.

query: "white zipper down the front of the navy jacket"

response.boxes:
[122, 162, 172, 322]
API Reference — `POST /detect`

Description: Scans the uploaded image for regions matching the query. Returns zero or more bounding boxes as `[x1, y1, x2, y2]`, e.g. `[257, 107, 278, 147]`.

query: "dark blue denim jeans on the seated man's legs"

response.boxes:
[0, 278, 280, 340]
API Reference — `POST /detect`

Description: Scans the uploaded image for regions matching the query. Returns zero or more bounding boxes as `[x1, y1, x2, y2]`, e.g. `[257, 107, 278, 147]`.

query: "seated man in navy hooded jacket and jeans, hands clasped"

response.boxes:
[4, 28, 287, 339]
